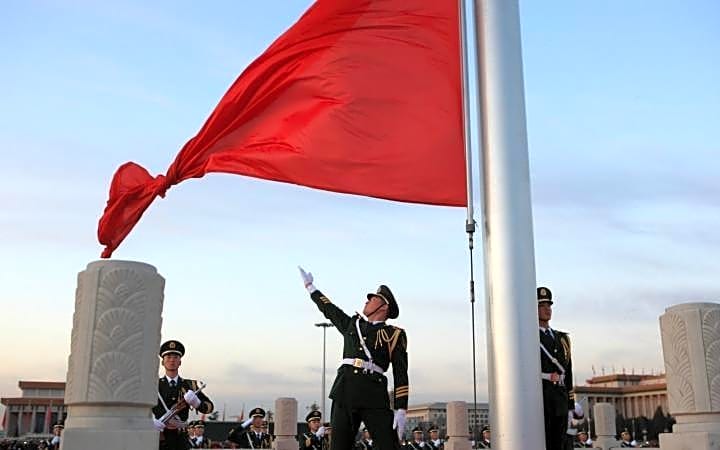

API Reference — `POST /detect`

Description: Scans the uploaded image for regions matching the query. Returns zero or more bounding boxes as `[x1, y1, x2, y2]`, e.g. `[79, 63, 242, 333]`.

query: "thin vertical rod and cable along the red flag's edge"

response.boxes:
[458, 0, 478, 442]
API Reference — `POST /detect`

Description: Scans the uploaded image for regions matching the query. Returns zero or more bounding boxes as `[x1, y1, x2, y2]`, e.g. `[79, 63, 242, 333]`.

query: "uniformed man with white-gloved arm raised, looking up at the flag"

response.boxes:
[300, 268, 409, 450]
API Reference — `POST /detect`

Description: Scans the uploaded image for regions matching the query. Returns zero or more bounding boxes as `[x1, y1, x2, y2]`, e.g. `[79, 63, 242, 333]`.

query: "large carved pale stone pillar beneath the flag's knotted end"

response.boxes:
[62, 260, 165, 450]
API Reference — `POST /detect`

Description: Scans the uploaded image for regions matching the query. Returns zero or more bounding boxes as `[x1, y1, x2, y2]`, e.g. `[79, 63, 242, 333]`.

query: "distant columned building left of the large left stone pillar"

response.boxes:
[0, 381, 67, 437]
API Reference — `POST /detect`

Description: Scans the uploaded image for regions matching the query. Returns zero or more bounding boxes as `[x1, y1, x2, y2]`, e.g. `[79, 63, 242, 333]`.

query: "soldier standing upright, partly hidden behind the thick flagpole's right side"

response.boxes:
[537, 287, 575, 450]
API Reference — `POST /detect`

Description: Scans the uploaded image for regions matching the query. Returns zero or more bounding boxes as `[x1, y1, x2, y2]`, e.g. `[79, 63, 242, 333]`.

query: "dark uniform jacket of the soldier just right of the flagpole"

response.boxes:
[540, 330, 575, 416]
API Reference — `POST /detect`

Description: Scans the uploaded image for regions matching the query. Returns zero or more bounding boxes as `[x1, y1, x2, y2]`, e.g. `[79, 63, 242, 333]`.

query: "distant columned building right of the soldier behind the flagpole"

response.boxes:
[575, 374, 668, 418]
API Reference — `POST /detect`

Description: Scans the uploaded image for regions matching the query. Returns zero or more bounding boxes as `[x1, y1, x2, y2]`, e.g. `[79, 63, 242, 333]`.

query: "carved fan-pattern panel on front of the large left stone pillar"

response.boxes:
[88, 268, 147, 402]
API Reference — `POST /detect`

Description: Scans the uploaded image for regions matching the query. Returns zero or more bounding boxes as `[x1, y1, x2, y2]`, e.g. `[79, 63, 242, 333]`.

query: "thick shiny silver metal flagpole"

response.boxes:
[475, 0, 545, 450]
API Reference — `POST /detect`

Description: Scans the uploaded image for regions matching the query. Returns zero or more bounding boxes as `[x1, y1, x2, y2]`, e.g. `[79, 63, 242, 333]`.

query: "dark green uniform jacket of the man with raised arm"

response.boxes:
[310, 291, 409, 409]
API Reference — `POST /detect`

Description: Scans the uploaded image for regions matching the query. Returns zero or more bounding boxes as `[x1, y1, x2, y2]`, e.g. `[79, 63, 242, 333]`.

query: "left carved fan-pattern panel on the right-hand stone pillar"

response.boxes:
[662, 314, 695, 413]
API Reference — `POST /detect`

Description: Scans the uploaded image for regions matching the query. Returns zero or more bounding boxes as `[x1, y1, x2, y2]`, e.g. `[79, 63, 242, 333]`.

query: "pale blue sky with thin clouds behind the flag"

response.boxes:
[0, 0, 720, 422]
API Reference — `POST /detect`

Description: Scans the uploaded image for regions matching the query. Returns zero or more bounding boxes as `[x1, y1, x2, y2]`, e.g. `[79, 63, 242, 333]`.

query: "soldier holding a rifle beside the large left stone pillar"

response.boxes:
[153, 340, 214, 450]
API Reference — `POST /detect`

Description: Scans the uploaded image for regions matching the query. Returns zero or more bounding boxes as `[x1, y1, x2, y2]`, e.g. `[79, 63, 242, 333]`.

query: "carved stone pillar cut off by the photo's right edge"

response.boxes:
[660, 303, 720, 450]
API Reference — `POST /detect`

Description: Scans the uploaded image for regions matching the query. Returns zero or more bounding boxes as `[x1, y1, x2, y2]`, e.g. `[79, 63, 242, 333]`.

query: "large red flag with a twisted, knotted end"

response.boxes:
[98, 0, 466, 258]
